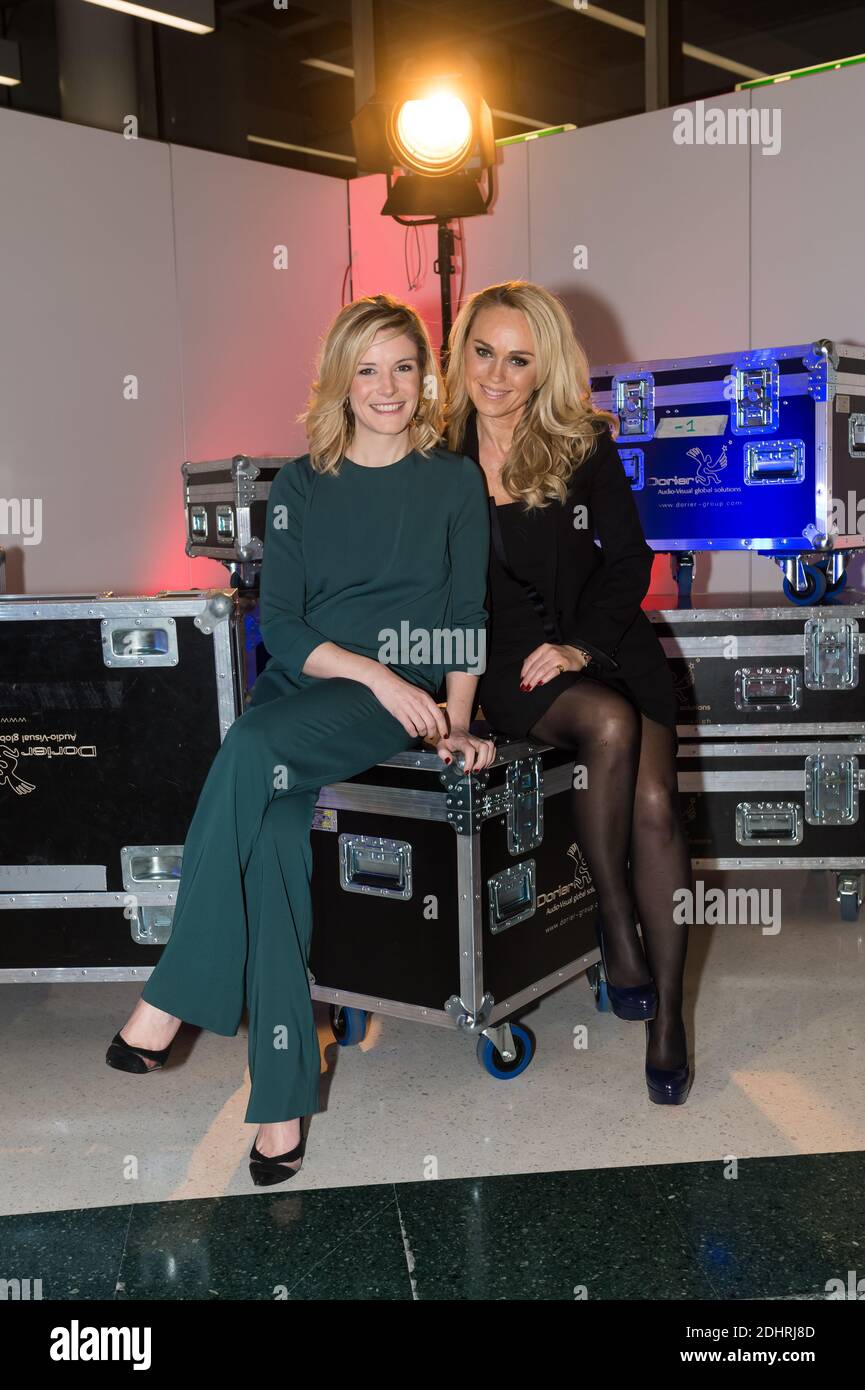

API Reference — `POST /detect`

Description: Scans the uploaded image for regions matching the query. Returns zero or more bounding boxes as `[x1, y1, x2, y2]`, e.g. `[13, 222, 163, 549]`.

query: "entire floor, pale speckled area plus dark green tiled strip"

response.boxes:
[0, 873, 865, 1298]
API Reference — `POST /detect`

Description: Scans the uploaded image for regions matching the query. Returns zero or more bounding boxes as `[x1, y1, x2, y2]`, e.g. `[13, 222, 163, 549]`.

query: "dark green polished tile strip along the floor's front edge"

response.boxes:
[0, 1152, 865, 1301]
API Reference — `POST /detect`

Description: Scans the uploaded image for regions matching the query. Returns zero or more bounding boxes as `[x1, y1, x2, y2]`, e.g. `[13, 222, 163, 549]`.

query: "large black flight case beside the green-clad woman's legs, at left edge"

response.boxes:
[0, 589, 242, 981]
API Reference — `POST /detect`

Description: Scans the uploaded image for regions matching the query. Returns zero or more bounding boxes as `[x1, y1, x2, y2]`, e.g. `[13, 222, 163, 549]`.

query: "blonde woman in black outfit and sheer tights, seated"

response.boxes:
[448, 281, 693, 1105]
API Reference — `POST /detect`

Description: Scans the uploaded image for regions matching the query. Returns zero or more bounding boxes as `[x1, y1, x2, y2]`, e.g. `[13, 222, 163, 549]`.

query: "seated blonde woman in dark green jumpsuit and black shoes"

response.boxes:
[106, 295, 495, 1184]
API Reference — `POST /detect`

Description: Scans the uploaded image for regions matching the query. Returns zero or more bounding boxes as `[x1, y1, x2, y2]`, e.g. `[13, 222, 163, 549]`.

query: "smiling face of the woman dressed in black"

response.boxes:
[464, 304, 538, 418]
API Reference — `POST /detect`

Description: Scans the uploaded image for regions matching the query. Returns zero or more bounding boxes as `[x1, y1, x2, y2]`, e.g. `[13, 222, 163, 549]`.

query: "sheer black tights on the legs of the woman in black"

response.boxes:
[530, 677, 693, 1068]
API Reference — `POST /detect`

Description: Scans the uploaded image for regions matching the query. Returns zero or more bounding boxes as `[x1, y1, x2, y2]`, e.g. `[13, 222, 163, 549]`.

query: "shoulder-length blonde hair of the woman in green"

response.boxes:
[298, 295, 444, 473]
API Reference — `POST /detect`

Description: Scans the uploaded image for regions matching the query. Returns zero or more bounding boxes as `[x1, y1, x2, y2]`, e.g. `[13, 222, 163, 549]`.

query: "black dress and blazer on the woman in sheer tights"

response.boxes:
[460, 413, 679, 746]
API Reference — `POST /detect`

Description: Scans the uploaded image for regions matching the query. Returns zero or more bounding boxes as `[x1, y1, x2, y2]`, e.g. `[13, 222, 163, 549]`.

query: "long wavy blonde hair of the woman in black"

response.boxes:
[446, 279, 619, 507]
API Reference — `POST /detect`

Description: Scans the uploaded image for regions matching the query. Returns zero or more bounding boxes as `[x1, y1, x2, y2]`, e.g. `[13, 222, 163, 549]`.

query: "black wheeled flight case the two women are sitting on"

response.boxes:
[310, 741, 605, 1076]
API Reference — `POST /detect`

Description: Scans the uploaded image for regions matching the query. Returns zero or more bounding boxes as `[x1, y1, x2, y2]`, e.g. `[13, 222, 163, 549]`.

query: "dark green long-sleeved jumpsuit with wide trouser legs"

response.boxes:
[142, 449, 490, 1123]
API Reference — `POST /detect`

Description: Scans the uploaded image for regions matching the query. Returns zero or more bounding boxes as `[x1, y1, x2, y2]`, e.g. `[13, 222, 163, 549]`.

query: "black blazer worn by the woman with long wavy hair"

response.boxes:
[459, 410, 666, 677]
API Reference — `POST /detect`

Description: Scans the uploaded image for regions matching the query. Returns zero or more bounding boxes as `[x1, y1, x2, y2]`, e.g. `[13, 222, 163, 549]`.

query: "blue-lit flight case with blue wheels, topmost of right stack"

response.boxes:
[592, 338, 865, 602]
